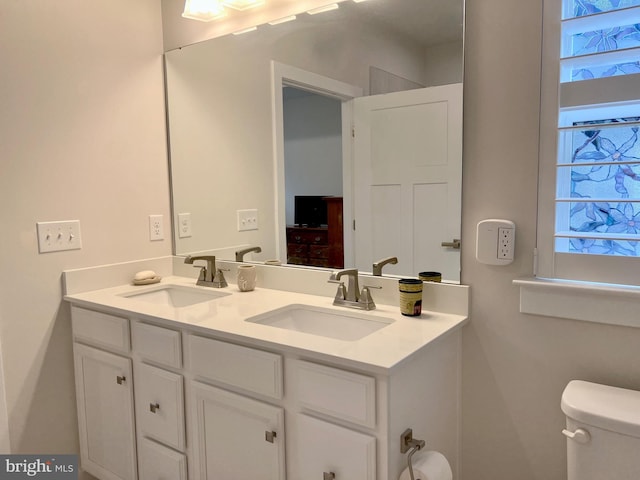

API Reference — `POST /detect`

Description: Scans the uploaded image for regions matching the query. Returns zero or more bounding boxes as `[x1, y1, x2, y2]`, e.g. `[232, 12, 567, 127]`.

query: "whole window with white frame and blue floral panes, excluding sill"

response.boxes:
[537, 0, 640, 285]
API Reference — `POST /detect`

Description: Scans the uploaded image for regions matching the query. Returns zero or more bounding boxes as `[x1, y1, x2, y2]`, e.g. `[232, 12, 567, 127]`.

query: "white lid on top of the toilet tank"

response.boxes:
[561, 380, 640, 438]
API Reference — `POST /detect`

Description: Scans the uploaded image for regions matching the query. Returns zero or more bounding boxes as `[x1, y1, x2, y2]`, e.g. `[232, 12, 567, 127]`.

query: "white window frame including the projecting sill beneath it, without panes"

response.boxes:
[513, 0, 640, 327]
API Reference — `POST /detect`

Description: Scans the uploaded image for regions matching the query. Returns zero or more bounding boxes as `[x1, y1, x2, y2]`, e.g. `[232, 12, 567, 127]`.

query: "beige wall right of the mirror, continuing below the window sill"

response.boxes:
[462, 0, 640, 480]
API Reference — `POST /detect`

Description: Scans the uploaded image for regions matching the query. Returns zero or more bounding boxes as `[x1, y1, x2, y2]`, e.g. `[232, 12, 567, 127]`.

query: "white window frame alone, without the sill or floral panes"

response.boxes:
[534, 0, 640, 285]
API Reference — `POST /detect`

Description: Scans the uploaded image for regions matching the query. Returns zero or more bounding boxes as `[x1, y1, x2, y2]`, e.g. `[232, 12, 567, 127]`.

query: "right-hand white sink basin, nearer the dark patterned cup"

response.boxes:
[246, 305, 393, 341]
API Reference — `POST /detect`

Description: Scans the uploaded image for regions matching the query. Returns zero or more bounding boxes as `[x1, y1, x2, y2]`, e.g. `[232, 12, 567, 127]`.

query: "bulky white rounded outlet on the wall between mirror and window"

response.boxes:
[476, 218, 516, 265]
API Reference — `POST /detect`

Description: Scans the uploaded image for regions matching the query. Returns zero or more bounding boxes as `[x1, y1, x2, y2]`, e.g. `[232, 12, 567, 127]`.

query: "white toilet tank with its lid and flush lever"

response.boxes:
[561, 380, 640, 480]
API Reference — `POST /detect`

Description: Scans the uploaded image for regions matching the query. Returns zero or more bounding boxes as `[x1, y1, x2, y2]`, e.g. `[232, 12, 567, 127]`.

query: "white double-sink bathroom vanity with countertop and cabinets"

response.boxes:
[65, 260, 467, 480]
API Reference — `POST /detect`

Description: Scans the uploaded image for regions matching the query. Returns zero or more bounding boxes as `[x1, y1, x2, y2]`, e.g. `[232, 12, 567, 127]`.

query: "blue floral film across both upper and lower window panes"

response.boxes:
[555, 0, 640, 256]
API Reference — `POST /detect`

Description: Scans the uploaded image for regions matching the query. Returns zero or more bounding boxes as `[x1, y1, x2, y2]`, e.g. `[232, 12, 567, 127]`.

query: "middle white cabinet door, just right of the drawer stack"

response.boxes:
[191, 382, 285, 480]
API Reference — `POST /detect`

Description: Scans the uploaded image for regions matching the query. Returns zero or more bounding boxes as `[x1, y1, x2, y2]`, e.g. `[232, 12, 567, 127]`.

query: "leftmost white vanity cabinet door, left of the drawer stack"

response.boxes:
[74, 343, 137, 480]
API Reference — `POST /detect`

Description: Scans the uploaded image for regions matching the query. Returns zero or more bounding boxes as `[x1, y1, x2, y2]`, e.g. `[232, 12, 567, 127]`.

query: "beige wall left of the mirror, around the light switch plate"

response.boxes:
[0, 0, 171, 464]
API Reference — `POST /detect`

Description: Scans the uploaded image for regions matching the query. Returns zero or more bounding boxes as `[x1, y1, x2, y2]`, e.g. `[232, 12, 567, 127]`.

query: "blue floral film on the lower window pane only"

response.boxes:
[556, 117, 640, 256]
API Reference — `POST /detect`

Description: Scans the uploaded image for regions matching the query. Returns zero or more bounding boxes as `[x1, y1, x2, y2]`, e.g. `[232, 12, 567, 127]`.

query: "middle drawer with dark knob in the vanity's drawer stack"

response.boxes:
[134, 363, 185, 450]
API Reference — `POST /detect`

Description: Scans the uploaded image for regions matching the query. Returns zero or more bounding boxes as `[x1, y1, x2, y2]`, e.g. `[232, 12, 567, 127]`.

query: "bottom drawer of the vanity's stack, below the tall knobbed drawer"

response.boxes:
[138, 438, 187, 480]
